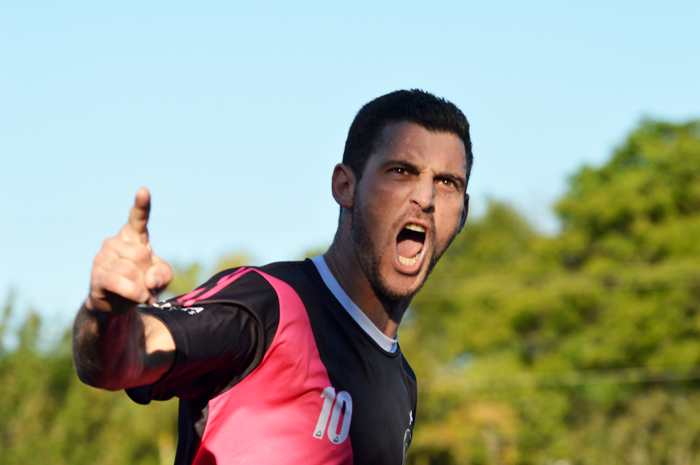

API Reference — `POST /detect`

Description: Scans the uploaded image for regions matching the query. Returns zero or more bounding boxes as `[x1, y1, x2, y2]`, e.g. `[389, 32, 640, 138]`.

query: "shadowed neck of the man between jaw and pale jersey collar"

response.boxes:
[323, 230, 411, 339]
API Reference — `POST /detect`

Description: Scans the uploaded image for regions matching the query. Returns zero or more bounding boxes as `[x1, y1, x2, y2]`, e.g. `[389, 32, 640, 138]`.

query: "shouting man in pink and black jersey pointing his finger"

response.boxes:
[73, 90, 472, 465]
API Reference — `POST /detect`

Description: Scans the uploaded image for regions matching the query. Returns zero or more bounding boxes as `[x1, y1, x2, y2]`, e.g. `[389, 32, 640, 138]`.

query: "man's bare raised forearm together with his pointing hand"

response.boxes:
[73, 188, 175, 390]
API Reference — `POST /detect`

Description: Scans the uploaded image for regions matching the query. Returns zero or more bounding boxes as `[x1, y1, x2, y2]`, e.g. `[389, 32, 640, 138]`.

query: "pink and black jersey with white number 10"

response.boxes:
[127, 256, 417, 465]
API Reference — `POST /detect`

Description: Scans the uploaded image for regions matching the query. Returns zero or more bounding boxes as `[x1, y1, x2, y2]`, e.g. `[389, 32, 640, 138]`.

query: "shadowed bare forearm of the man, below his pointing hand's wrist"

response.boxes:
[73, 305, 146, 390]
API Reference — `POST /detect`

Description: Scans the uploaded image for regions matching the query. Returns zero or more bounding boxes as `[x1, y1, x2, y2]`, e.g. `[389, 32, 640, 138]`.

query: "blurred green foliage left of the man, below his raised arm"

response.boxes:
[0, 301, 177, 465]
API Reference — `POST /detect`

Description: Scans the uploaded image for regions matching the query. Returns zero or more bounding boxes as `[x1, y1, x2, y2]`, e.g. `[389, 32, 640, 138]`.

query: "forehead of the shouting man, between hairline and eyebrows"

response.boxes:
[368, 122, 467, 175]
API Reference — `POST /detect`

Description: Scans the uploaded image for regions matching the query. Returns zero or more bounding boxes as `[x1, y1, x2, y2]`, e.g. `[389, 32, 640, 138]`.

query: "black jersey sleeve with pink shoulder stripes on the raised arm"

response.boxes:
[127, 268, 279, 403]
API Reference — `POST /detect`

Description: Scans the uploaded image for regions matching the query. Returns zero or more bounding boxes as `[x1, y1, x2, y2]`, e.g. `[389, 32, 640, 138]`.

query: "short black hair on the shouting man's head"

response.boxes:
[343, 89, 474, 181]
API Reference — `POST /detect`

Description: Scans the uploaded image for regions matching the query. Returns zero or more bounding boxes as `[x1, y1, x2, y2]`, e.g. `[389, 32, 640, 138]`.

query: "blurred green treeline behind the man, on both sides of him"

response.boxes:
[0, 121, 700, 465]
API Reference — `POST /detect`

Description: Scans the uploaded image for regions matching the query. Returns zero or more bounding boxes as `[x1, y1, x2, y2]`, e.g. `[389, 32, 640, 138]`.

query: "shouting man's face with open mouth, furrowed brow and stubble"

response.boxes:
[352, 123, 466, 301]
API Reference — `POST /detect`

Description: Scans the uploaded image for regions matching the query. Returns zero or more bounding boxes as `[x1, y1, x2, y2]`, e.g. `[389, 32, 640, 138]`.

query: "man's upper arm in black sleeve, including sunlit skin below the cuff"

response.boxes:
[131, 272, 279, 400]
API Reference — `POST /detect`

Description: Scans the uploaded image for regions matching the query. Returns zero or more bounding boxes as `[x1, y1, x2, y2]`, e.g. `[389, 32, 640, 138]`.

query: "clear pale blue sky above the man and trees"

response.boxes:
[0, 1, 700, 326]
